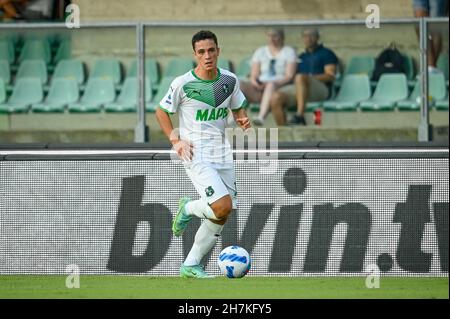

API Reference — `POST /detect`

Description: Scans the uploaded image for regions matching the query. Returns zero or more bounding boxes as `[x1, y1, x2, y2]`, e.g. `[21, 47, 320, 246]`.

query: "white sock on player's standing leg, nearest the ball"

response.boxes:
[183, 219, 223, 266]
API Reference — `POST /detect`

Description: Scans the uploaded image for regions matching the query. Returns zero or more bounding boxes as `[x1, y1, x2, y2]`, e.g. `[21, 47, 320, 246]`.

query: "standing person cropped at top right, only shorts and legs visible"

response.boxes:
[413, 0, 448, 72]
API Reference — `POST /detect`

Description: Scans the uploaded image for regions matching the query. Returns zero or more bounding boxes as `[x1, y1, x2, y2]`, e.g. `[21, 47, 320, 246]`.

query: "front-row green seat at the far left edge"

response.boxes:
[0, 78, 44, 113]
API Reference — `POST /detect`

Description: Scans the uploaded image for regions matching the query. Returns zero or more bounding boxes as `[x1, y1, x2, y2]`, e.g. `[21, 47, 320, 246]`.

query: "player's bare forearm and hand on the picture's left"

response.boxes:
[156, 107, 192, 160]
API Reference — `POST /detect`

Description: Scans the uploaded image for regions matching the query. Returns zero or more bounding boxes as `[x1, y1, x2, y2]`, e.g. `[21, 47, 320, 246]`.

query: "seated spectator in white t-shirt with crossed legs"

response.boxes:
[240, 29, 297, 125]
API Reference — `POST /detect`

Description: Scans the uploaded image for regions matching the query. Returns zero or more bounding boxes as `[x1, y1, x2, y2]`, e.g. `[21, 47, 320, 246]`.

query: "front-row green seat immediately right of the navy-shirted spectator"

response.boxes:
[322, 74, 371, 111]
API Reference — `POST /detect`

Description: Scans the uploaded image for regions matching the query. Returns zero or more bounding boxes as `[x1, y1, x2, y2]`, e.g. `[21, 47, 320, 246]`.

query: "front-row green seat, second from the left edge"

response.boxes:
[31, 78, 79, 112]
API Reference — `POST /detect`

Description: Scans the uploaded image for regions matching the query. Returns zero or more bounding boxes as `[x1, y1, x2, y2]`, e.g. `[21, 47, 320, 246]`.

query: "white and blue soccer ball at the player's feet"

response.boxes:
[217, 246, 251, 278]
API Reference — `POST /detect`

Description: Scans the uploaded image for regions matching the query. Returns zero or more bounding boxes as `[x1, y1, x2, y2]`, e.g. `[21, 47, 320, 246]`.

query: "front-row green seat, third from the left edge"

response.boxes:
[68, 78, 116, 113]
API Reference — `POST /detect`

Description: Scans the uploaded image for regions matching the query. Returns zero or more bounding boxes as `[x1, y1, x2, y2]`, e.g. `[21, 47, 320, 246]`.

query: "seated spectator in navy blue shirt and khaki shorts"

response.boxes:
[270, 29, 338, 125]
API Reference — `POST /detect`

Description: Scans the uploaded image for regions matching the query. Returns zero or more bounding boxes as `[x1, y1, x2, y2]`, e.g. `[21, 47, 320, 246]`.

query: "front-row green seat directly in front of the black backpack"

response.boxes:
[359, 73, 408, 111]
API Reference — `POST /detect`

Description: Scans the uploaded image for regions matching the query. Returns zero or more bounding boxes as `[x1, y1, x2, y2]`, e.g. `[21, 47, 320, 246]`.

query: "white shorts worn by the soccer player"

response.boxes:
[184, 162, 237, 209]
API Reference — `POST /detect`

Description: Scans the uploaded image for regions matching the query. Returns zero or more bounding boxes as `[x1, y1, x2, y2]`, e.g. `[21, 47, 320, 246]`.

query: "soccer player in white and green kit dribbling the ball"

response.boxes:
[156, 31, 250, 278]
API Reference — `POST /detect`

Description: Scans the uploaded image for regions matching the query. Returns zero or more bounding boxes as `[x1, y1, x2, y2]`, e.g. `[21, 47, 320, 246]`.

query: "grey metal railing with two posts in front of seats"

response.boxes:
[0, 18, 449, 142]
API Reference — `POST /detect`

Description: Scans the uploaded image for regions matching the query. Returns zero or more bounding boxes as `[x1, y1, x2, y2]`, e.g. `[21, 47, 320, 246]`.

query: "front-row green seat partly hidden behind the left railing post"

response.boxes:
[105, 77, 153, 112]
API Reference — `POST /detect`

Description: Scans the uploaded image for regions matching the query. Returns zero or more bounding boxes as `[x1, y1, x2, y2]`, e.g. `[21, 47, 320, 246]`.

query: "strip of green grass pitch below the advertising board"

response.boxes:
[0, 275, 449, 299]
